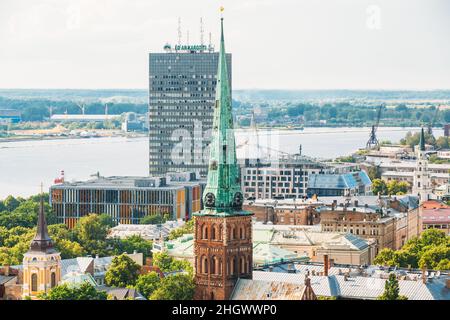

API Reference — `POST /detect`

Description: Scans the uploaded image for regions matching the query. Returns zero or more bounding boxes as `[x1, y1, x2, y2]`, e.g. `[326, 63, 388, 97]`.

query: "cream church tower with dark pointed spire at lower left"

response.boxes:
[22, 190, 61, 298]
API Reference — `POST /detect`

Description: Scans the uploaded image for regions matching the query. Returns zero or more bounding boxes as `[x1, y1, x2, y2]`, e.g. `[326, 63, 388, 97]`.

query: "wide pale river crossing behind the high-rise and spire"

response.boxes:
[0, 127, 443, 199]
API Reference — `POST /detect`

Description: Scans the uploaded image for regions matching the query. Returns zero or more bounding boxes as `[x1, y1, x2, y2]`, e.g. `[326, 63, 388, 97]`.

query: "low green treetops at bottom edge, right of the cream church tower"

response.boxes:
[40, 282, 108, 300]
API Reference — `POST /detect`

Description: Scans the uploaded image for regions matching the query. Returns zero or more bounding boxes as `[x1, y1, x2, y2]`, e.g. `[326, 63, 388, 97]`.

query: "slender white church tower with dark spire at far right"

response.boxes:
[412, 128, 432, 202]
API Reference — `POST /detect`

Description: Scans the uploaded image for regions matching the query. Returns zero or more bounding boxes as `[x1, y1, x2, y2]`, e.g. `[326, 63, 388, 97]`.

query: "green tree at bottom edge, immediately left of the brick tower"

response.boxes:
[150, 273, 195, 300]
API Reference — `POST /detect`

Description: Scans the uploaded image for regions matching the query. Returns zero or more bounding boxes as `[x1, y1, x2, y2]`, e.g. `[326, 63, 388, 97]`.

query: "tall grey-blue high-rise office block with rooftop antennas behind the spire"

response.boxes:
[149, 45, 231, 176]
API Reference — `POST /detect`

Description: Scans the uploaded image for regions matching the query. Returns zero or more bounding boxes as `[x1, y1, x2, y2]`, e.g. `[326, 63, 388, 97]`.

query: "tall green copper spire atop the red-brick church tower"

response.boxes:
[199, 18, 250, 215]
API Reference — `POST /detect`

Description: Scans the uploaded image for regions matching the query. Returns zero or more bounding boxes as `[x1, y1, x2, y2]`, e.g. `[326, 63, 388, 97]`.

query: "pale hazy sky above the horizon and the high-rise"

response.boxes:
[0, 0, 450, 90]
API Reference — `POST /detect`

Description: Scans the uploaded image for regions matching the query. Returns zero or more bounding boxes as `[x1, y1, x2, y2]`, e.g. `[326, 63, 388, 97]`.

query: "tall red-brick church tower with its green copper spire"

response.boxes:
[194, 18, 253, 300]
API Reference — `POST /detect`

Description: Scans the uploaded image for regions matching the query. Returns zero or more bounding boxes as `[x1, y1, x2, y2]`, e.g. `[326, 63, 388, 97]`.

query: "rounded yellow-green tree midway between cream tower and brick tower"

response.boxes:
[105, 254, 141, 287]
